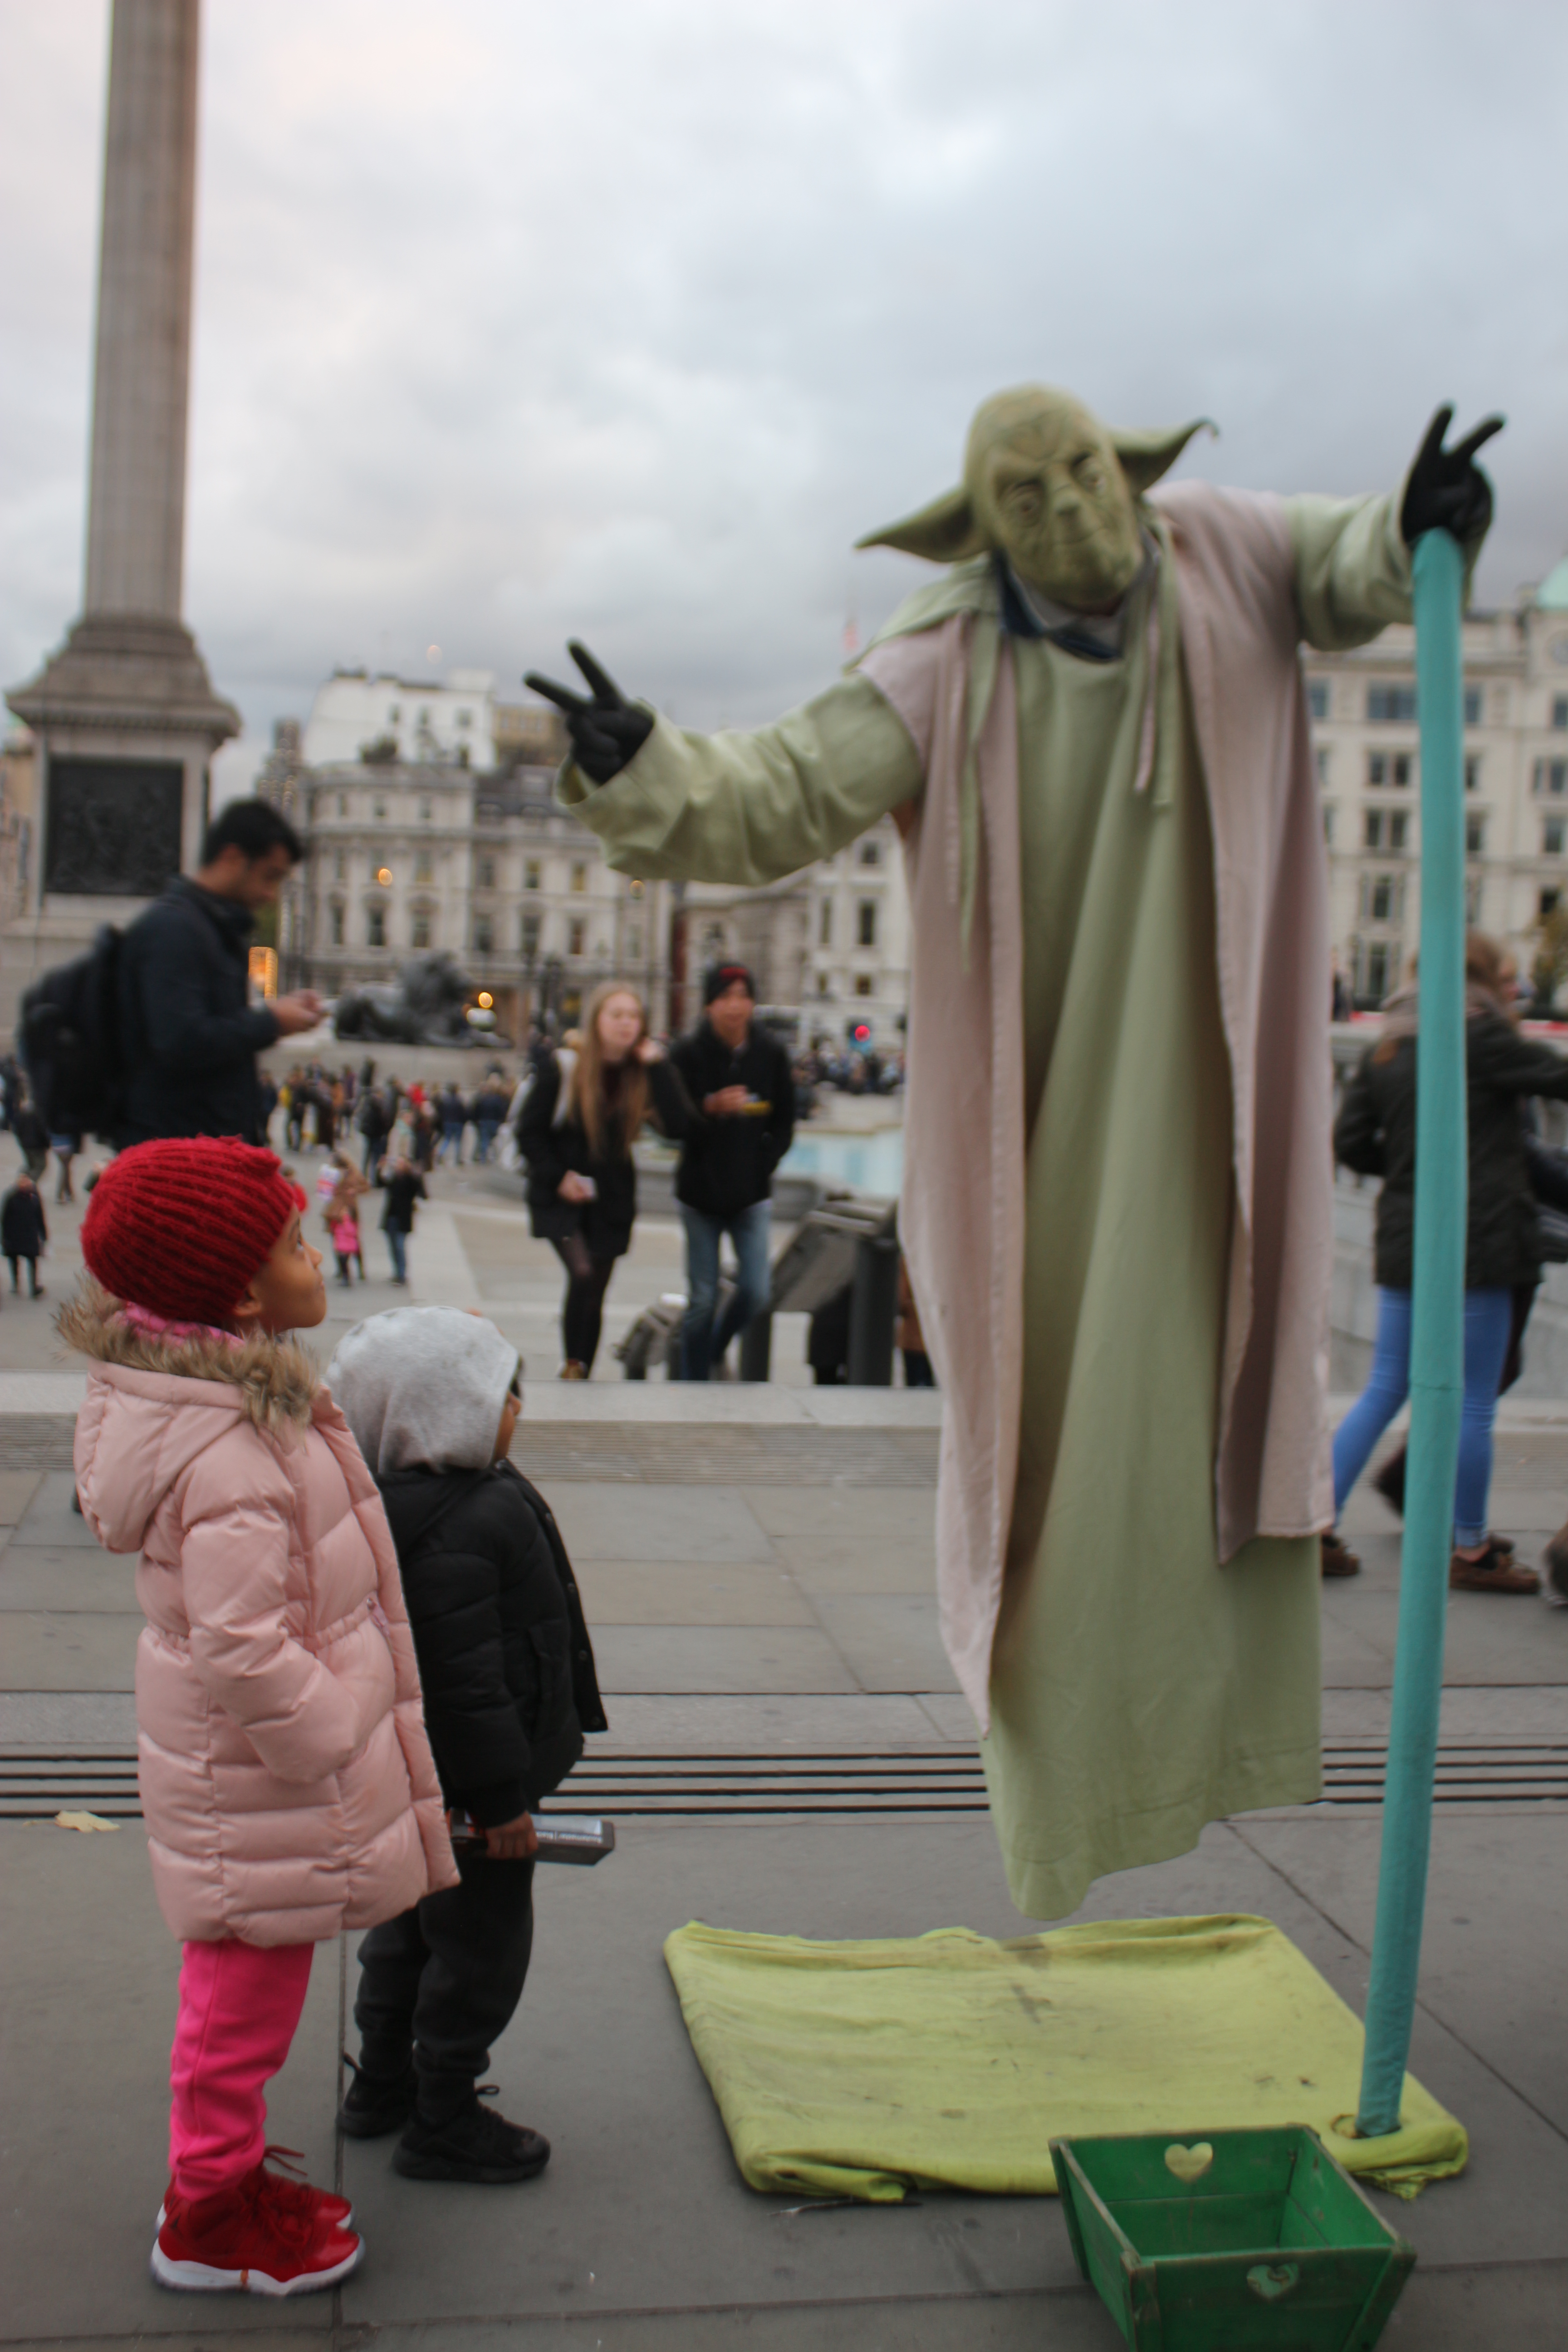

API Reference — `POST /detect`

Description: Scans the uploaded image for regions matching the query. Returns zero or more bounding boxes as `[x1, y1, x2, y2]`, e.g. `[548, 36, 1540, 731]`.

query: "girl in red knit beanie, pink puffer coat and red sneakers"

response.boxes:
[61, 1138, 456, 2296]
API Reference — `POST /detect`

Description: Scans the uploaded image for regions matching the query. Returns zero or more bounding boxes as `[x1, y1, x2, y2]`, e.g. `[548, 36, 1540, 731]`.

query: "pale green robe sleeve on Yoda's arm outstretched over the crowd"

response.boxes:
[555, 677, 924, 887]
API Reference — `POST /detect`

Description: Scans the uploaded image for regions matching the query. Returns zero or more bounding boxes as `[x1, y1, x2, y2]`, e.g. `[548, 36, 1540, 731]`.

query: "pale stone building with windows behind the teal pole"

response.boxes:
[1305, 558, 1568, 1007]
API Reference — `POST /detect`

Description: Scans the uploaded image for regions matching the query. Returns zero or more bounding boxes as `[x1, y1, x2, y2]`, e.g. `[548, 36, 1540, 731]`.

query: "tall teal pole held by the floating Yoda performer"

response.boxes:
[1357, 532, 1467, 2138]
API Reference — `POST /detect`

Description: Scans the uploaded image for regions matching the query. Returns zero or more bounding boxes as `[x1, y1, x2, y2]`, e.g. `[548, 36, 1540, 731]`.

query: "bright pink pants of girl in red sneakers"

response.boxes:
[169, 1940, 315, 2197]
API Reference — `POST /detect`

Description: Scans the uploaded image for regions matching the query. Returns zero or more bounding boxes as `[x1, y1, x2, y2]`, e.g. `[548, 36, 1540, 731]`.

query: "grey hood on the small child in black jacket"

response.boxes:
[327, 1308, 519, 1477]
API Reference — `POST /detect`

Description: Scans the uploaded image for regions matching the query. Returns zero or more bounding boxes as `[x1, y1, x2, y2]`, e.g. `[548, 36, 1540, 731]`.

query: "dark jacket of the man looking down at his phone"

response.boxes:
[115, 875, 277, 1146]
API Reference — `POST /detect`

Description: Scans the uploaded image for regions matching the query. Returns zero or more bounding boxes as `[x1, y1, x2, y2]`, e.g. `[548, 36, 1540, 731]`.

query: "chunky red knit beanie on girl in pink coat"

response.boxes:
[82, 1136, 306, 1324]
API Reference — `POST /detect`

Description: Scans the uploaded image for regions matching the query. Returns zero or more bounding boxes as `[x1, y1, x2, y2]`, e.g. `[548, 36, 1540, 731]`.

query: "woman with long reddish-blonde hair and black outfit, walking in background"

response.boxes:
[517, 981, 689, 1381]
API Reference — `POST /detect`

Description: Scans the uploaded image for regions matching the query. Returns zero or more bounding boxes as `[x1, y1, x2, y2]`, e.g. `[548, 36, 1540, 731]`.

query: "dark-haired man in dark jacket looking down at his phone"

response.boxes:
[115, 800, 322, 1146]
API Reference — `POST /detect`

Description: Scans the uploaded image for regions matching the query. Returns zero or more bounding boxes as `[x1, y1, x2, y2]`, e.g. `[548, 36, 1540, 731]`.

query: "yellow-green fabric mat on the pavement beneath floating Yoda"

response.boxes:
[665, 1915, 1469, 2201]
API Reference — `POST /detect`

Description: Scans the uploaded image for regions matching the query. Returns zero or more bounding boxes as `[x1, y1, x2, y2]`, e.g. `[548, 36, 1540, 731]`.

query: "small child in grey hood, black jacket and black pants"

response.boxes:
[327, 1308, 609, 2183]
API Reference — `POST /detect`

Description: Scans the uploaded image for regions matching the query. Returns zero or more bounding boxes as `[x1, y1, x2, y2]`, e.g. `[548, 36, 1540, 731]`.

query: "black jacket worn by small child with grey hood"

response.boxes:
[381, 1463, 609, 1828]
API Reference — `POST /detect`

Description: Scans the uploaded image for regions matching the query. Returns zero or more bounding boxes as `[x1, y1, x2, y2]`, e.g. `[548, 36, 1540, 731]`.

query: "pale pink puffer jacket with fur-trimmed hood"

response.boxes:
[61, 1291, 456, 1945]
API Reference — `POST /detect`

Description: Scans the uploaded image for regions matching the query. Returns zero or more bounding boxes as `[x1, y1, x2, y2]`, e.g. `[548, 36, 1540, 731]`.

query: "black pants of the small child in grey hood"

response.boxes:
[355, 1853, 534, 2122]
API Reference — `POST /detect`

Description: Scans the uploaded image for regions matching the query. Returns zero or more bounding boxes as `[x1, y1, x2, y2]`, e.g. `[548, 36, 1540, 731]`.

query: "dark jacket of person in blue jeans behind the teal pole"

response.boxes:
[1333, 1014, 1568, 1291]
